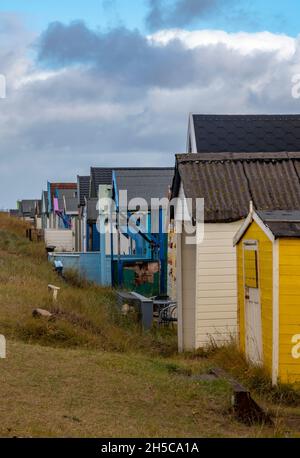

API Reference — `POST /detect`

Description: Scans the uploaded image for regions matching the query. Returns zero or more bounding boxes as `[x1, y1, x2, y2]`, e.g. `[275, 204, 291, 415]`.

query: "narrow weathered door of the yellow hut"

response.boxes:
[244, 241, 263, 365]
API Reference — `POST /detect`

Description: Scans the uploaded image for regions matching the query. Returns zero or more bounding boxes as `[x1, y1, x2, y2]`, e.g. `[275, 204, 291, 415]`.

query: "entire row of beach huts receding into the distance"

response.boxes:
[11, 114, 300, 385]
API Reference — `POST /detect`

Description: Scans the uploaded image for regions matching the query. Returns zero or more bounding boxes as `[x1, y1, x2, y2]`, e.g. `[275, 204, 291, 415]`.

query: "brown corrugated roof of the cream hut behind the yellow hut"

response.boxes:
[172, 153, 300, 222]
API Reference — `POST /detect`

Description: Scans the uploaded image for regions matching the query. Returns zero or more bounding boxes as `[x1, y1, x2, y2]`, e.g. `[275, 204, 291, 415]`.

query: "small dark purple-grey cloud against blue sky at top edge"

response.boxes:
[146, 0, 233, 31]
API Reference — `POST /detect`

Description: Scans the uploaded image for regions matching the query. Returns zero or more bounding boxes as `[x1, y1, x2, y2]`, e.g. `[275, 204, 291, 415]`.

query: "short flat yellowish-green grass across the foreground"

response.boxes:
[0, 342, 273, 437]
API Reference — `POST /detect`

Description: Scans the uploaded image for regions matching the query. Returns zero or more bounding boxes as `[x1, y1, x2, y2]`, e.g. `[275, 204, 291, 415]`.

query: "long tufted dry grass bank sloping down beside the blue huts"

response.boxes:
[0, 214, 176, 354]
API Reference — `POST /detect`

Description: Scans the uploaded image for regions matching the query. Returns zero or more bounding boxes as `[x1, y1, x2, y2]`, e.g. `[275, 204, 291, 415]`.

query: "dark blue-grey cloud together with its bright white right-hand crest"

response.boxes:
[38, 22, 295, 93]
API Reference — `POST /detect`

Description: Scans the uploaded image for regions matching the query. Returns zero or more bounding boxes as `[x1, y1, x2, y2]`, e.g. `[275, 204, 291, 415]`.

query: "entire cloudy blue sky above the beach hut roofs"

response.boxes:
[0, 0, 300, 208]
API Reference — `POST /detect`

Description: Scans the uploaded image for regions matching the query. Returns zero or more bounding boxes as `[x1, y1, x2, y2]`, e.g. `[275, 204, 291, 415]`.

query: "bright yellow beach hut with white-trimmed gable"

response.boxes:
[234, 210, 300, 385]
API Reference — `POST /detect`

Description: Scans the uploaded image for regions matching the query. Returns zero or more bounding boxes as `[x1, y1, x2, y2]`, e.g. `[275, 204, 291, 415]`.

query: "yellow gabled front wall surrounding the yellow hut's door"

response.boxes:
[237, 222, 273, 375]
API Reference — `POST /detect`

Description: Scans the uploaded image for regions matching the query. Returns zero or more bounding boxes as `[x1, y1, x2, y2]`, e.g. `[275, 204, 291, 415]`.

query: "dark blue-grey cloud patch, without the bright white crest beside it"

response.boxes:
[38, 22, 202, 87]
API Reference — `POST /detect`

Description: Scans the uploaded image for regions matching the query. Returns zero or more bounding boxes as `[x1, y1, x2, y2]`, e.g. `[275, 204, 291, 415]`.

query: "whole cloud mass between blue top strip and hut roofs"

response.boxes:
[0, 18, 300, 207]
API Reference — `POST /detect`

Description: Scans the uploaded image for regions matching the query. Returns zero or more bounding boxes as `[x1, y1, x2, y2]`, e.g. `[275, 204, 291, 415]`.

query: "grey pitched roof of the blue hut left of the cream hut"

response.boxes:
[115, 167, 174, 209]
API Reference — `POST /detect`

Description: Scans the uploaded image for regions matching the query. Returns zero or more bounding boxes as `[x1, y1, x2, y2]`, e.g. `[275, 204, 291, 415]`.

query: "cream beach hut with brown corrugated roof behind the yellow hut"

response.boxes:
[172, 153, 300, 351]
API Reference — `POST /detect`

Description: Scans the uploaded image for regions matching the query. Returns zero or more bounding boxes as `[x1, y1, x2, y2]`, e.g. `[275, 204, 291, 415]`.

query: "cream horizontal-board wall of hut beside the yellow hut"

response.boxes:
[195, 221, 242, 348]
